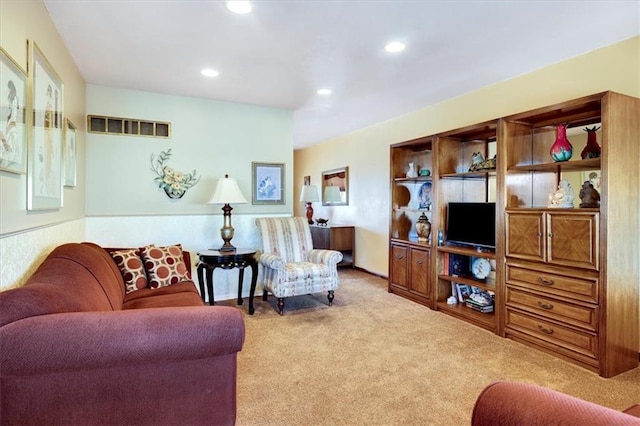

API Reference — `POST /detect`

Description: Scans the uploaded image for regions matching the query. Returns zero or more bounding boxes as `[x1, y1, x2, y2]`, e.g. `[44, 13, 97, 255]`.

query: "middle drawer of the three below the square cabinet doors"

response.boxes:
[507, 287, 598, 332]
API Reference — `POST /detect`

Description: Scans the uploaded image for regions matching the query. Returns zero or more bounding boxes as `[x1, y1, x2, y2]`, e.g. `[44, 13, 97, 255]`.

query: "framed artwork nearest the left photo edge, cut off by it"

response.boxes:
[0, 47, 28, 174]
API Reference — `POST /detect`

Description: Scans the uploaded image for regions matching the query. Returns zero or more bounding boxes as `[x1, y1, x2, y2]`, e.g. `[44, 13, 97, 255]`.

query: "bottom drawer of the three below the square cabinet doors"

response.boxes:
[505, 308, 598, 358]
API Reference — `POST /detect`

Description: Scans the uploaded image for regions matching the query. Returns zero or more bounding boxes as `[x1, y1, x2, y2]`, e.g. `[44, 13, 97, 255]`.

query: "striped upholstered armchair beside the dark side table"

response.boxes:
[256, 217, 342, 315]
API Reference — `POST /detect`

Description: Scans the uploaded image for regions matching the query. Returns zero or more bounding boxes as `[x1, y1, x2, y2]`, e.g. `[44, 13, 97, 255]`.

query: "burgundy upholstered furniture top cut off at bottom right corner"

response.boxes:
[471, 381, 640, 426]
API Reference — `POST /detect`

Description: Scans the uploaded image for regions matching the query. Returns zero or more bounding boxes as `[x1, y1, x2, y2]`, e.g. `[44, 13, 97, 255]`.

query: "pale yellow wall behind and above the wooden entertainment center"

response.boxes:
[294, 36, 640, 276]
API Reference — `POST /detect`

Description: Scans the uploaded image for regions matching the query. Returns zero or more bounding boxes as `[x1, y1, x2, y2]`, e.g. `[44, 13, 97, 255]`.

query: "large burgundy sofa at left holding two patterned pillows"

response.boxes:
[0, 243, 244, 425]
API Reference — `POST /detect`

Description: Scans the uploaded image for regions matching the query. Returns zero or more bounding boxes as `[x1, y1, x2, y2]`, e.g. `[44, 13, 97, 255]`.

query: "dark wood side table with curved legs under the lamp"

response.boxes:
[198, 249, 258, 315]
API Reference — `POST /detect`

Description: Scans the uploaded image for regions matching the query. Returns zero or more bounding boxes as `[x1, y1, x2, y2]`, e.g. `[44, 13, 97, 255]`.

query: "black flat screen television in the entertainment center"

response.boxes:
[447, 203, 496, 249]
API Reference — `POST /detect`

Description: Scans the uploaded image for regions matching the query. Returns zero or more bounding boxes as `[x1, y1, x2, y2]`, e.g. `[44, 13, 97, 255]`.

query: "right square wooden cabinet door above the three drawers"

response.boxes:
[546, 212, 599, 271]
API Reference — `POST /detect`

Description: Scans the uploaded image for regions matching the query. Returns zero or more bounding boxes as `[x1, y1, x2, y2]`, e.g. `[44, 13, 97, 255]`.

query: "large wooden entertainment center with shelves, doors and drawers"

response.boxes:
[389, 92, 640, 377]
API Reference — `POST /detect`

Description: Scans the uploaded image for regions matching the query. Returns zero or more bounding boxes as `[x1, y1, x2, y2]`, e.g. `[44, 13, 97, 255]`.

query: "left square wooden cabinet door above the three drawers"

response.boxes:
[506, 211, 546, 262]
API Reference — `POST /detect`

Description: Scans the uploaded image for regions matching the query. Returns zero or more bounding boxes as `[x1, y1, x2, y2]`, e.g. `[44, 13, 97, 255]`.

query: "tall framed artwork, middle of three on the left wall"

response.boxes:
[27, 40, 64, 210]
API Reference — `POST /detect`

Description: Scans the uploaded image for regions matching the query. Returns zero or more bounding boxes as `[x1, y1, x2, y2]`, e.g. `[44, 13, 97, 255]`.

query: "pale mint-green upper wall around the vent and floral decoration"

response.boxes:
[87, 85, 293, 216]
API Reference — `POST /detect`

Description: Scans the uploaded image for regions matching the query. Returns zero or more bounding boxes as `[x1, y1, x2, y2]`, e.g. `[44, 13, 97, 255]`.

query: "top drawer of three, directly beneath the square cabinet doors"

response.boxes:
[507, 264, 598, 303]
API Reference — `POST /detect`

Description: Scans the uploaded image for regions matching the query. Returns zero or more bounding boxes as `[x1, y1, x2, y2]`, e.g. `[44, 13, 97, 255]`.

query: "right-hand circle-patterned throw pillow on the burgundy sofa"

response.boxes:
[140, 244, 191, 288]
